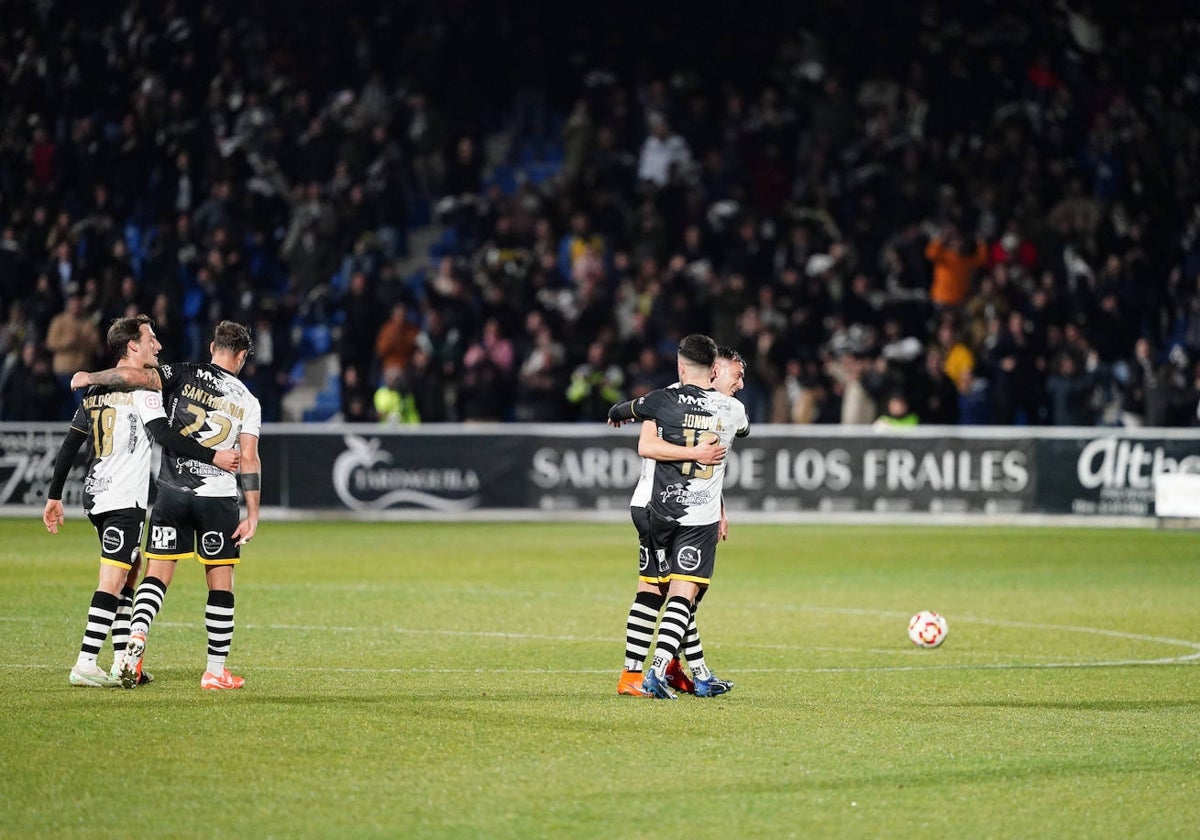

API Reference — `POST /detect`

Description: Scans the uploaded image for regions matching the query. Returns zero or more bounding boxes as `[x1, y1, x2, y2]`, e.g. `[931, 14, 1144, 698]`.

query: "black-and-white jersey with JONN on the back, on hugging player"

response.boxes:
[632, 385, 750, 524]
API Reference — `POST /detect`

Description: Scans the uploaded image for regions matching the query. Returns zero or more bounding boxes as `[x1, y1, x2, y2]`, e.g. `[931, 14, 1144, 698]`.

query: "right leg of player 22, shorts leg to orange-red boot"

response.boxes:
[196, 498, 246, 690]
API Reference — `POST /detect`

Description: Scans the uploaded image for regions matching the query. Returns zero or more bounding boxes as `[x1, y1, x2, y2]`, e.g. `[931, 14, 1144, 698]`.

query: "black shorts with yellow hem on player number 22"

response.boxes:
[145, 487, 241, 565]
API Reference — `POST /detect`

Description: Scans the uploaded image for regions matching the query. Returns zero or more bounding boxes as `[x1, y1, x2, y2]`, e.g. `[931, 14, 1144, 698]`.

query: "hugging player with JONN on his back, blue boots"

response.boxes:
[608, 335, 750, 700]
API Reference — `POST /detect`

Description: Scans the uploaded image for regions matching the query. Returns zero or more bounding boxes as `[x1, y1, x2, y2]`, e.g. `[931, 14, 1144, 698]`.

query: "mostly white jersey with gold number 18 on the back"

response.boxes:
[71, 388, 166, 514]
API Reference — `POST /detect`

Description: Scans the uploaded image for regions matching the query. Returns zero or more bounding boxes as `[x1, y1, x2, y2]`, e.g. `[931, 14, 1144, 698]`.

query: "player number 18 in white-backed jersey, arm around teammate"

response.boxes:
[42, 314, 240, 688]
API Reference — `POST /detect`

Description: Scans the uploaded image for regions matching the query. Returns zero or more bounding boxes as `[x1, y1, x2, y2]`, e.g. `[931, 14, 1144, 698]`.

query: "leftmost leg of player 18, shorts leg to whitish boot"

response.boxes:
[70, 510, 142, 688]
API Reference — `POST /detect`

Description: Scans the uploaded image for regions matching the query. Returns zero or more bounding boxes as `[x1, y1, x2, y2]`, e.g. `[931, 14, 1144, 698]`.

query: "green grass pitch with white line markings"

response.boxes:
[0, 511, 1200, 838]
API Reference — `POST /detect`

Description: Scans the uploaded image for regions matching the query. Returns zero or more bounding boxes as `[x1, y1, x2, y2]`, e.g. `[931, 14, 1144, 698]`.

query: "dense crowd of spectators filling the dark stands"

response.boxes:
[0, 0, 1200, 426]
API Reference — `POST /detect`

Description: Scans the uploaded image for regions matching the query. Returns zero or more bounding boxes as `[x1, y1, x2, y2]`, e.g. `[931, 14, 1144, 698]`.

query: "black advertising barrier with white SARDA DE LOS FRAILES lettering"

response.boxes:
[0, 424, 1200, 526]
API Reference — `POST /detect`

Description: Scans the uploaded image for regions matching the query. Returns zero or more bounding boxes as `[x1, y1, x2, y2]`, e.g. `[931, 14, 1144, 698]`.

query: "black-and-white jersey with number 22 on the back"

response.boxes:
[158, 362, 263, 498]
